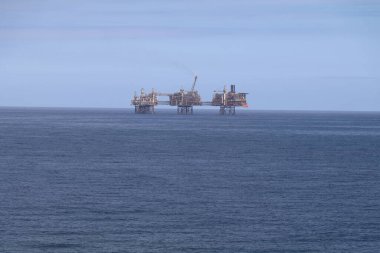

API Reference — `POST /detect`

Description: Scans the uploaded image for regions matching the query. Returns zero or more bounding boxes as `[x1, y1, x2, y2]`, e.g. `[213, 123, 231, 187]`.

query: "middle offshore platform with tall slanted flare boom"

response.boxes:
[169, 76, 202, 114]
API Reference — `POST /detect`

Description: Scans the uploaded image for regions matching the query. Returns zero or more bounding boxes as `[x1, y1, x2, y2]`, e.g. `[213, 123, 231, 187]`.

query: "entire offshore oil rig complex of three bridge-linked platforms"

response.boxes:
[131, 76, 248, 115]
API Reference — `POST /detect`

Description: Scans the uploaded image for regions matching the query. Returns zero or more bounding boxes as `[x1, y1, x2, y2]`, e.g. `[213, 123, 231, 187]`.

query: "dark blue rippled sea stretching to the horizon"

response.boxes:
[0, 108, 380, 253]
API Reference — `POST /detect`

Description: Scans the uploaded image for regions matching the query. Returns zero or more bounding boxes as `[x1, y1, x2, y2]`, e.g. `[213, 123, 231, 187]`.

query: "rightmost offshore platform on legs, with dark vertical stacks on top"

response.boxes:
[211, 85, 248, 115]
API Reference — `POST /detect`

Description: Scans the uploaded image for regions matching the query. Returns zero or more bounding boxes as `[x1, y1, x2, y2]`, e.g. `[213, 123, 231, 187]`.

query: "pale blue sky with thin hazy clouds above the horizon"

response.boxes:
[0, 0, 380, 111]
